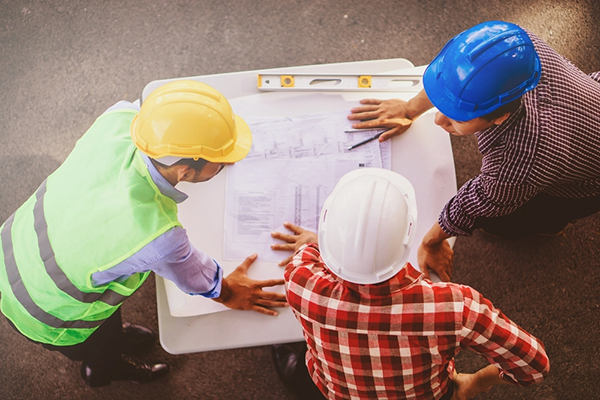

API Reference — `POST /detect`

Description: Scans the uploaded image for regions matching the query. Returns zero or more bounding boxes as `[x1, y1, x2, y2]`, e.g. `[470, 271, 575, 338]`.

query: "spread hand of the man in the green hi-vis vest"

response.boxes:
[214, 253, 288, 316]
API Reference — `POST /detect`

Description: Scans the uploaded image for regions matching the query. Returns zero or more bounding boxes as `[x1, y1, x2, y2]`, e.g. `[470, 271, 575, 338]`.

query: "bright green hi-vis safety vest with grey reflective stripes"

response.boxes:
[0, 110, 180, 346]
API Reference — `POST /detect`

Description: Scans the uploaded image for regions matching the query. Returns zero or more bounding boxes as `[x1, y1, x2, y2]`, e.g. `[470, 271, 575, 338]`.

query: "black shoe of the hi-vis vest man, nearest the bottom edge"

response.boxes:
[81, 360, 169, 387]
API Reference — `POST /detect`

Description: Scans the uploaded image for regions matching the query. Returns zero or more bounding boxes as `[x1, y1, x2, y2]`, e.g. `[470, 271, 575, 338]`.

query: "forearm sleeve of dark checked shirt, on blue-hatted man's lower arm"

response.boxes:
[438, 173, 541, 236]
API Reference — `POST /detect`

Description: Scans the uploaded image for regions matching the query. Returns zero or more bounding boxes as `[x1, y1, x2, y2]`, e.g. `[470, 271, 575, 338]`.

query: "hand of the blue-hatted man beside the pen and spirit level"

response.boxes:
[348, 99, 412, 142]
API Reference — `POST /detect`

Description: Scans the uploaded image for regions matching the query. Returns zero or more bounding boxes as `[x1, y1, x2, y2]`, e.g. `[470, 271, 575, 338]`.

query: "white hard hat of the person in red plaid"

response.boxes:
[319, 168, 417, 284]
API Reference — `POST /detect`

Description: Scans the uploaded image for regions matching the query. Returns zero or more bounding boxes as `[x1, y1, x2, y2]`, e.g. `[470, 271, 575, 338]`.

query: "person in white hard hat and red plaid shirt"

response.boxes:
[272, 168, 550, 400]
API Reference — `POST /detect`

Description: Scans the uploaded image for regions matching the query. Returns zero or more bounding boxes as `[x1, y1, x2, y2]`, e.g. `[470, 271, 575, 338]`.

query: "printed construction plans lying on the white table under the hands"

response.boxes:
[223, 113, 391, 261]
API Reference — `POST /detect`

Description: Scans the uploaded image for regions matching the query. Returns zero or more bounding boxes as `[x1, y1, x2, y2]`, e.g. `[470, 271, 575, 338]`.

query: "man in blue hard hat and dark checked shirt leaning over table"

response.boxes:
[348, 21, 600, 281]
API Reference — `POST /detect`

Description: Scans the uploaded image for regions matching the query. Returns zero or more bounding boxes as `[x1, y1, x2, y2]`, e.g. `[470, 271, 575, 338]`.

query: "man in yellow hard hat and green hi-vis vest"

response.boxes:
[0, 80, 286, 387]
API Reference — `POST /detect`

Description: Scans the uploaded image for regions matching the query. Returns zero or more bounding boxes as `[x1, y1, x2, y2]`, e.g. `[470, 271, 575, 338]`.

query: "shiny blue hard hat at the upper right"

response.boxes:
[423, 21, 542, 121]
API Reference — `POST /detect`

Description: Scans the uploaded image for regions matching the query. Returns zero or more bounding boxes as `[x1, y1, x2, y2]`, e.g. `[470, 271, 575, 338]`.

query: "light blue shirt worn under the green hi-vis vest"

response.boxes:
[92, 100, 223, 298]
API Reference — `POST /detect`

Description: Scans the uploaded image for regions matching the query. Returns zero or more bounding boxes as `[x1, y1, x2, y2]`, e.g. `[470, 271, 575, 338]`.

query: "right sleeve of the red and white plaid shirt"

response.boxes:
[460, 286, 550, 386]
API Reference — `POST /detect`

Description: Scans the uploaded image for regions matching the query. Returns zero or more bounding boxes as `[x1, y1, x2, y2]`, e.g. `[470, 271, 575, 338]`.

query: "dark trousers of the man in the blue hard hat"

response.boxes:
[474, 193, 600, 239]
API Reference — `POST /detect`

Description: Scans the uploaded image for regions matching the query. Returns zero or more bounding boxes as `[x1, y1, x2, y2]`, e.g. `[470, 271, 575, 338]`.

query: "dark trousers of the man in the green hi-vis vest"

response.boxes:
[7, 308, 123, 368]
